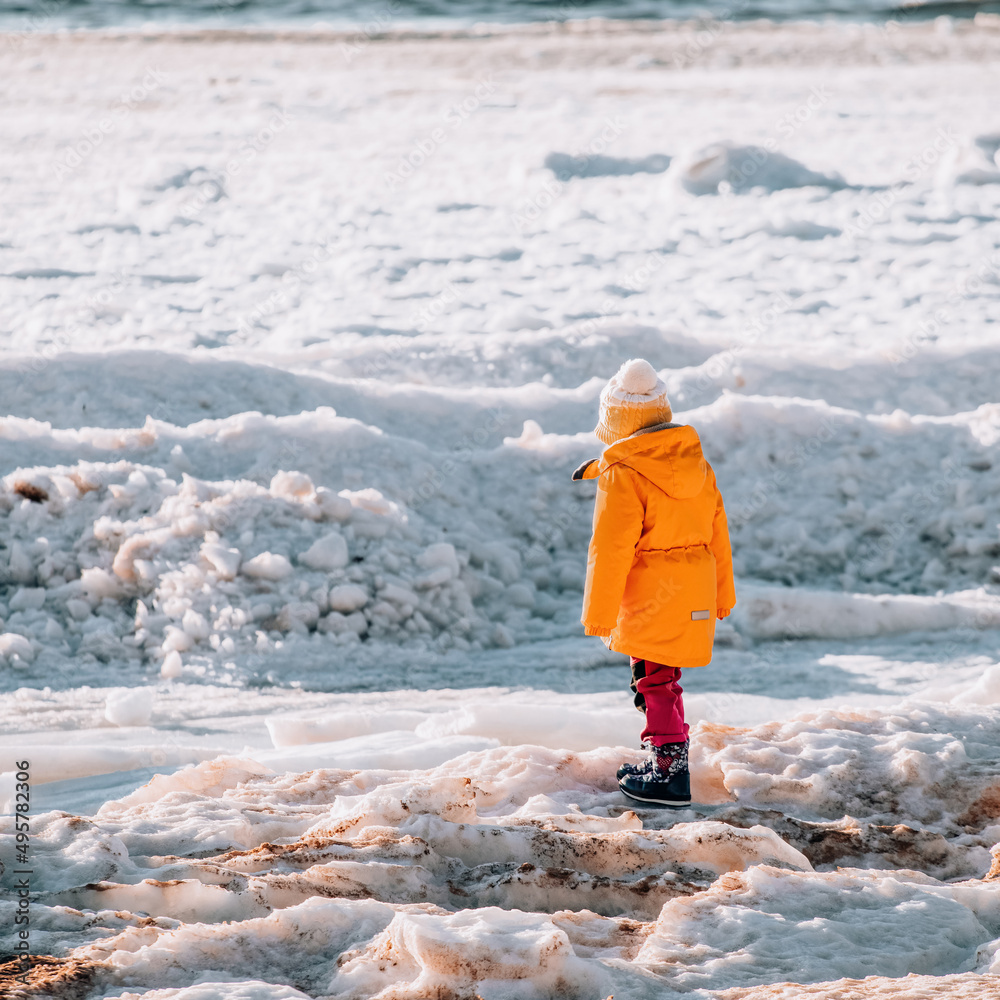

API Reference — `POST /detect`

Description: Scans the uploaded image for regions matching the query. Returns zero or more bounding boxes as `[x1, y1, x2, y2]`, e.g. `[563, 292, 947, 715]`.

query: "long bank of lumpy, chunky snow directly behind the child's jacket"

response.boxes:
[0, 382, 1000, 685]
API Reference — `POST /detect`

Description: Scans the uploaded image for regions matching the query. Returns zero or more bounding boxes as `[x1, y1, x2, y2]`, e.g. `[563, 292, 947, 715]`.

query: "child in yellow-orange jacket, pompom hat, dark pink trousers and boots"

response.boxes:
[573, 358, 736, 808]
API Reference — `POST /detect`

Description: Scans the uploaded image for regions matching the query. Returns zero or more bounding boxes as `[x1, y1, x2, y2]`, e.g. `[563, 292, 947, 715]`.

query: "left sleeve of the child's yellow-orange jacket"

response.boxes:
[581, 465, 646, 635]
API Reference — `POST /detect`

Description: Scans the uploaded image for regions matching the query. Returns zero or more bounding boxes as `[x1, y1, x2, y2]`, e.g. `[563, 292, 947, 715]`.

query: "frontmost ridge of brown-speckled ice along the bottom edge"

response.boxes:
[70, 880, 997, 1000]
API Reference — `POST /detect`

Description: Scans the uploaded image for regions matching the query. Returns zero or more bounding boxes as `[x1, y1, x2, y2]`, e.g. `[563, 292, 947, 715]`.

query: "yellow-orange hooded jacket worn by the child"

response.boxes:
[573, 423, 736, 667]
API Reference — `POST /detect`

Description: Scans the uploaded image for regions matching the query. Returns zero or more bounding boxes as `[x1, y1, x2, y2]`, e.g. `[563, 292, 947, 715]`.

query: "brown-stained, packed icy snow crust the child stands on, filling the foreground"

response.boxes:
[2, 703, 1000, 998]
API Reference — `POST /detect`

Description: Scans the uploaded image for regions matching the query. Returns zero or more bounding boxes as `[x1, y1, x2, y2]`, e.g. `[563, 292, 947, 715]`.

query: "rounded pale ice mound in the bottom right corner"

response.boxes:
[636, 867, 1000, 989]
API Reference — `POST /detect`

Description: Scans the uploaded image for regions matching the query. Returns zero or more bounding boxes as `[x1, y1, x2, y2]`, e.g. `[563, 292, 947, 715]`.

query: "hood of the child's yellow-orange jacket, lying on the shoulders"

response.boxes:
[588, 424, 708, 500]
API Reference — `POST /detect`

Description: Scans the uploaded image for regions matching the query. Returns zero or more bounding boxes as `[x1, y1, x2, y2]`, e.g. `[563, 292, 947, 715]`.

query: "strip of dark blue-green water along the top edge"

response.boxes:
[0, 0, 1000, 31]
